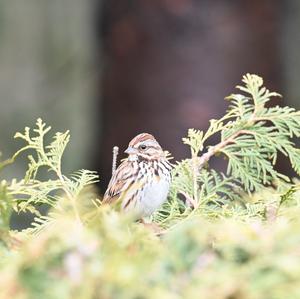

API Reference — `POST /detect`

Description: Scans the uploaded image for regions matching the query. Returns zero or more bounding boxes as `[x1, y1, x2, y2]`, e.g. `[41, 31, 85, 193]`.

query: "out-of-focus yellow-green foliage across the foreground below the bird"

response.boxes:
[0, 207, 300, 299]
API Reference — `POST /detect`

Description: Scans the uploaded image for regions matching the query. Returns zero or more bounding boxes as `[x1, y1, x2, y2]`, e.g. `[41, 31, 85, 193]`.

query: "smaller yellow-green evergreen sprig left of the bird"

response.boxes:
[8, 118, 98, 227]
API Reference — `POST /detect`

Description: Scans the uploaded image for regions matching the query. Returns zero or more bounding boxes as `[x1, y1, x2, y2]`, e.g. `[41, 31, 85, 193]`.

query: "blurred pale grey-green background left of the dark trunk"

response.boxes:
[0, 0, 96, 177]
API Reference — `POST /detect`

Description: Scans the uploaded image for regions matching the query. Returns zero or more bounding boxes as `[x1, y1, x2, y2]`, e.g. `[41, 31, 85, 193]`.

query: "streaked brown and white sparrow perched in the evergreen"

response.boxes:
[103, 133, 171, 218]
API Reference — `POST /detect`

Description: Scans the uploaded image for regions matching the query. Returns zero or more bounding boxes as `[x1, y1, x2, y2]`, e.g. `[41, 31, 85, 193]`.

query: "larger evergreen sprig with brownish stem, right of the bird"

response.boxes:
[158, 74, 300, 227]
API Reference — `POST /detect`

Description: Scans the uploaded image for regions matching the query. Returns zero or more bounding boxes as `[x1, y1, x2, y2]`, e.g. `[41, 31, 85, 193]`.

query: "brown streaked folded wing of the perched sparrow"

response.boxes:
[103, 160, 137, 204]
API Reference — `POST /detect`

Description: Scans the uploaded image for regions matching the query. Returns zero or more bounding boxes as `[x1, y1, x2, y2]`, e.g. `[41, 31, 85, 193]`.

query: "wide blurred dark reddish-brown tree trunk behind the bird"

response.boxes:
[97, 0, 281, 188]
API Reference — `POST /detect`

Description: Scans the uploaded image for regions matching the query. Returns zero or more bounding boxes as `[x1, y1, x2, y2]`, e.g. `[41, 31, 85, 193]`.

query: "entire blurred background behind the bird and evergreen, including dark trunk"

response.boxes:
[0, 0, 300, 189]
